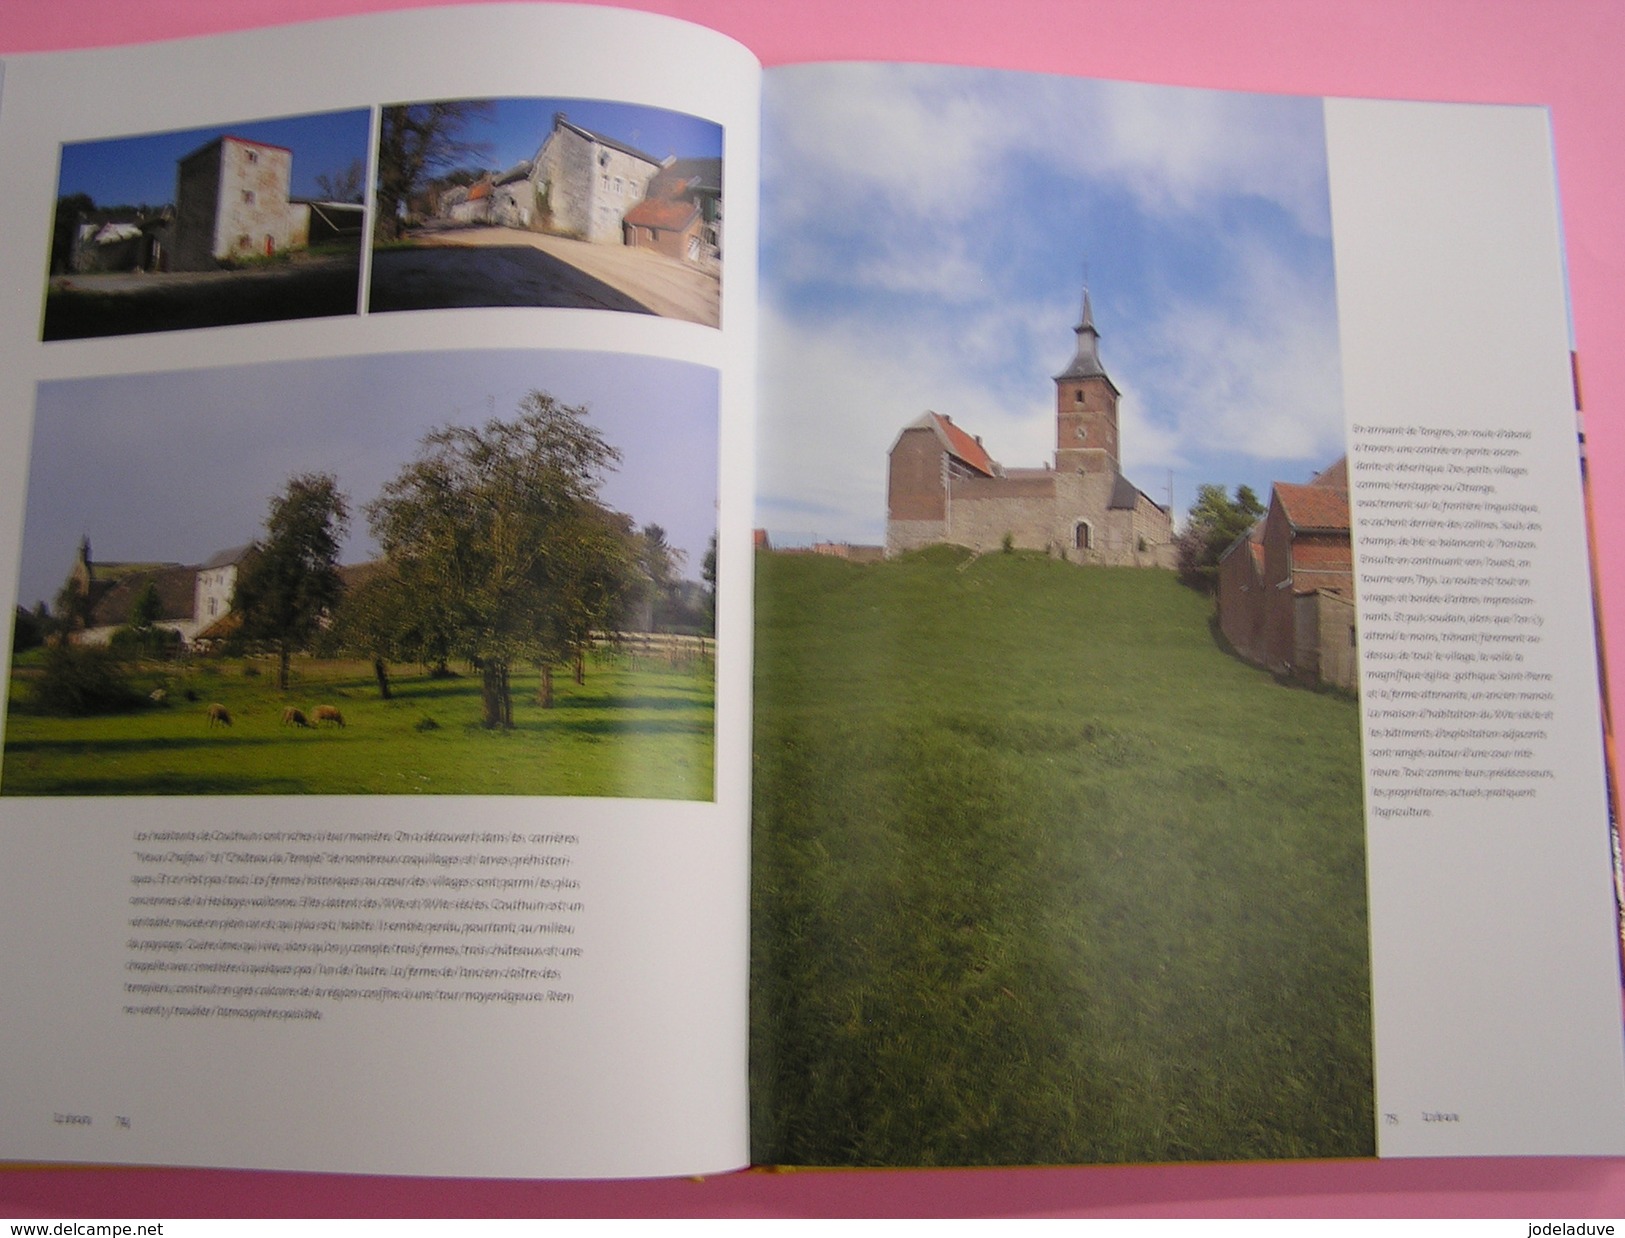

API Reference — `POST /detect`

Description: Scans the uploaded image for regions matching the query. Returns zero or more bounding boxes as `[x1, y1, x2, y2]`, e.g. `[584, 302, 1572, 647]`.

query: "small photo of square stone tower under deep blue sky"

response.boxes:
[41, 110, 372, 340]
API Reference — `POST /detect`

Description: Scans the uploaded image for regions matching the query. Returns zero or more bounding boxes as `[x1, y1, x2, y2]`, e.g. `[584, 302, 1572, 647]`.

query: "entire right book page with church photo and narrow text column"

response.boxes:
[752, 65, 1625, 1165]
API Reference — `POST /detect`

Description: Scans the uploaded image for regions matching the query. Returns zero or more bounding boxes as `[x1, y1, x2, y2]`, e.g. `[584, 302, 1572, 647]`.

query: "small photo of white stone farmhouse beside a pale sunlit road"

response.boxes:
[369, 99, 723, 327]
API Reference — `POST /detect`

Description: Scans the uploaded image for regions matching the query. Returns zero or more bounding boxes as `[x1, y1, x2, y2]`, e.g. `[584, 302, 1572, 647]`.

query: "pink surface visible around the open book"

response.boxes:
[0, 0, 1625, 1219]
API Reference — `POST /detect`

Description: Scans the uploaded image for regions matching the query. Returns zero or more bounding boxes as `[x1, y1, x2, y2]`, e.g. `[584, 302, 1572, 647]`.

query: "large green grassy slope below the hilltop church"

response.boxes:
[751, 548, 1375, 1165]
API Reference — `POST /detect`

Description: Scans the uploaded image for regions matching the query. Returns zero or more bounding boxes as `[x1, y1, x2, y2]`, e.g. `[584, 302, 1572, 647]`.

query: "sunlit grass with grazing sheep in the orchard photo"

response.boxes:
[0, 653, 715, 799]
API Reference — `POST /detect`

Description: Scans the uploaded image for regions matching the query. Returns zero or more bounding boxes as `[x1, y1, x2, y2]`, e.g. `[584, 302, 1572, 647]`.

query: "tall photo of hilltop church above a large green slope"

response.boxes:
[751, 65, 1375, 1167]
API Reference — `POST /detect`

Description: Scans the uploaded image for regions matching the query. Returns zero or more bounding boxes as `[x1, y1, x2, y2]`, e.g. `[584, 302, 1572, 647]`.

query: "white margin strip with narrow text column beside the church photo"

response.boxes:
[1326, 101, 1625, 1157]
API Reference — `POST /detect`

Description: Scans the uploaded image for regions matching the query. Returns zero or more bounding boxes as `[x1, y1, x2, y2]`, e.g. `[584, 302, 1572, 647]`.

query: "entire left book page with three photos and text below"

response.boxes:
[0, 6, 759, 1176]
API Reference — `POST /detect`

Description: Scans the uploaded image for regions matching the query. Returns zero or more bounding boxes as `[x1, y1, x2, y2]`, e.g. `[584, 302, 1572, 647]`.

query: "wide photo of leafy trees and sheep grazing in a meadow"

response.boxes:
[0, 351, 718, 799]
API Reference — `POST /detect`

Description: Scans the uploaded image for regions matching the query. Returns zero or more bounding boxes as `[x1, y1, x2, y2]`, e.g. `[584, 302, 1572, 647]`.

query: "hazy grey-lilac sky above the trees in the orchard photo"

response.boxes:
[18, 351, 718, 606]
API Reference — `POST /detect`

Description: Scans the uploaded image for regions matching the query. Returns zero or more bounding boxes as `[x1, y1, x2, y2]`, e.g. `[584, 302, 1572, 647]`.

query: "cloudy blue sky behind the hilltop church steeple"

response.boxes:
[757, 65, 1344, 543]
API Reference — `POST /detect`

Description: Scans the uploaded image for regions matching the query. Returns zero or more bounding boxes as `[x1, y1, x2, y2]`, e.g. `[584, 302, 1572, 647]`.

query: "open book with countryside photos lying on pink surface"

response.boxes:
[0, 5, 1625, 1176]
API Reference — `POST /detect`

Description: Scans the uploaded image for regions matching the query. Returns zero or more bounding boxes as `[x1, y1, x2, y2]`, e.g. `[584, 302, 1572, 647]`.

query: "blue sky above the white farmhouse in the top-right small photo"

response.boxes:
[390, 99, 722, 171]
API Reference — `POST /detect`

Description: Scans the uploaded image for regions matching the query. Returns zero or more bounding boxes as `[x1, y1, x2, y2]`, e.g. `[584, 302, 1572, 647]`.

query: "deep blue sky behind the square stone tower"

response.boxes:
[57, 109, 372, 206]
